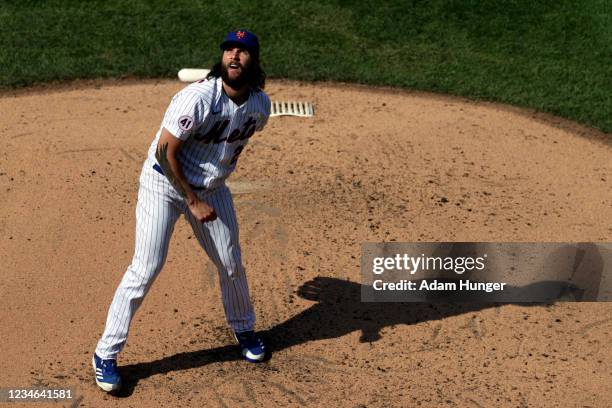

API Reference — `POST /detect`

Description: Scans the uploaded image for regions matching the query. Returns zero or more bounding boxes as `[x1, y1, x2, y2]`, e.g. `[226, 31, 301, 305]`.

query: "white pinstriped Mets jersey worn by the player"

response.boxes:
[147, 78, 270, 188]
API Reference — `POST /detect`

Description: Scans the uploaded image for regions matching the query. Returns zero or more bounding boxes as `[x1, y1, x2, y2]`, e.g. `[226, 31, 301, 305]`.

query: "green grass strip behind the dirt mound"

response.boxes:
[0, 0, 612, 133]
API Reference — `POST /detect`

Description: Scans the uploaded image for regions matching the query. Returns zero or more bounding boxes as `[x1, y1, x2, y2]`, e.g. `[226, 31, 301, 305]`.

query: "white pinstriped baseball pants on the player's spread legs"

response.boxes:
[96, 160, 255, 359]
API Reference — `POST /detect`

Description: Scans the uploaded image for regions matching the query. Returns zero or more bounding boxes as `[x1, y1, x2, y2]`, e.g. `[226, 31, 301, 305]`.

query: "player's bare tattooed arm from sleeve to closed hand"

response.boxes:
[155, 128, 217, 222]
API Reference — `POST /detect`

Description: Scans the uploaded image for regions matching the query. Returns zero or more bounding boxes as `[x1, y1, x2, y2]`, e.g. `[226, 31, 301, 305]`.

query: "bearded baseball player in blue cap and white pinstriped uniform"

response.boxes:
[93, 30, 270, 392]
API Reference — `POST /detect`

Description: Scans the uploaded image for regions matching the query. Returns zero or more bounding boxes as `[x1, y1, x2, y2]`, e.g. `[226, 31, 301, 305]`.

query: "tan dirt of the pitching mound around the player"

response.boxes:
[0, 81, 612, 407]
